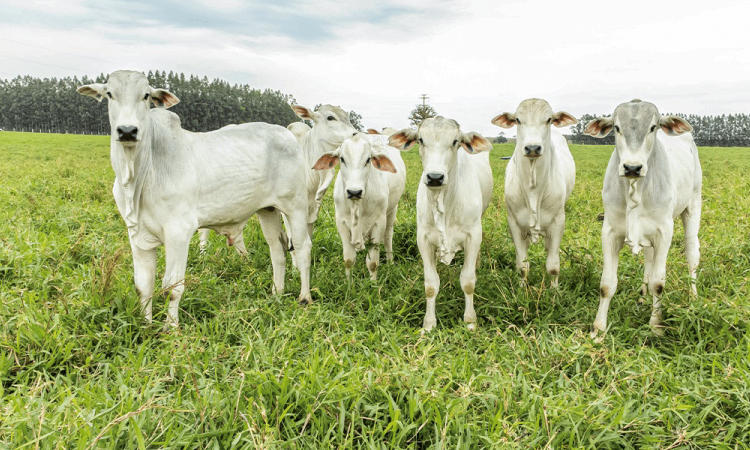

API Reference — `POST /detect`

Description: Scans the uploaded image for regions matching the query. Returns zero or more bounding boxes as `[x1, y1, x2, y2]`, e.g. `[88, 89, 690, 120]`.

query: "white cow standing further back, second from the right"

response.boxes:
[492, 98, 578, 287]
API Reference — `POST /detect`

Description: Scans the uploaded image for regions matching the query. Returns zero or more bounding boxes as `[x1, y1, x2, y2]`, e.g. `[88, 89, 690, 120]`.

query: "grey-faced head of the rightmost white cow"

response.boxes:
[584, 100, 693, 178]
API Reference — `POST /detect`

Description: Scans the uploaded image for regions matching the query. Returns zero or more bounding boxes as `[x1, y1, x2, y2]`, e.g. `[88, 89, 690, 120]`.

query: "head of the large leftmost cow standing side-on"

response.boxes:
[78, 70, 180, 147]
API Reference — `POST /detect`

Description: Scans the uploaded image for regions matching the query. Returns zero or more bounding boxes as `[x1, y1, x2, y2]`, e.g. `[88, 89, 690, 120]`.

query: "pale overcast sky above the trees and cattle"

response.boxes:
[0, 0, 750, 136]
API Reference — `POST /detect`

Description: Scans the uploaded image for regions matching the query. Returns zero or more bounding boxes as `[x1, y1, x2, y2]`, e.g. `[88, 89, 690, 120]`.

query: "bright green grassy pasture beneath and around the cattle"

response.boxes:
[0, 132, 750, 450]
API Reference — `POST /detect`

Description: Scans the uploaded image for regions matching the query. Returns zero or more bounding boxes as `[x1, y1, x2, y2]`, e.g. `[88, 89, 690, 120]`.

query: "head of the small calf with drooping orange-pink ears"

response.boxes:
[313, 133, 396, 200]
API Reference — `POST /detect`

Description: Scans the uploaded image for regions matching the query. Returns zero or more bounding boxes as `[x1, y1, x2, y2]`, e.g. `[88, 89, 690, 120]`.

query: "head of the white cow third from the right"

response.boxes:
[389, 116, 492, 188]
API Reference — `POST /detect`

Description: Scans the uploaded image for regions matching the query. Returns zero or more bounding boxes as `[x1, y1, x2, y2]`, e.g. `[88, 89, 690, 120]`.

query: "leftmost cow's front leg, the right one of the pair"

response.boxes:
[162, 227, 195, 330]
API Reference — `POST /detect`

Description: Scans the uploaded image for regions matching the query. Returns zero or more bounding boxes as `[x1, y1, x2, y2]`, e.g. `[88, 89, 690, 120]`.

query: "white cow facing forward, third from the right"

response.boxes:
[389, 116, 492, 330]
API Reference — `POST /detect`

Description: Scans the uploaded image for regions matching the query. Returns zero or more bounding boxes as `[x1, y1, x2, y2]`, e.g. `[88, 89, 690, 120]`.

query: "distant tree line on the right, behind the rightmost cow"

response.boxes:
[570, 113, 750, 147]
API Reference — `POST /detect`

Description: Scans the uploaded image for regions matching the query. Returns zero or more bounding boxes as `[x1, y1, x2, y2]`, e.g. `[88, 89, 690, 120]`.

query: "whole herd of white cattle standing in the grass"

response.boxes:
[78, 71, 702, 336]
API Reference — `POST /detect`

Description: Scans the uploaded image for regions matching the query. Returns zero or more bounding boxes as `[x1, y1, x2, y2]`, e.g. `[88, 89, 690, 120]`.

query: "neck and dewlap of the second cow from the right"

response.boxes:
[513, 139, 556, 243]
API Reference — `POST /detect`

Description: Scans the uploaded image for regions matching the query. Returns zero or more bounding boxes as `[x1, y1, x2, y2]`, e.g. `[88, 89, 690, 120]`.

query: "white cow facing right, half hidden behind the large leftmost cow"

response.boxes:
[292, 105, 357, 238]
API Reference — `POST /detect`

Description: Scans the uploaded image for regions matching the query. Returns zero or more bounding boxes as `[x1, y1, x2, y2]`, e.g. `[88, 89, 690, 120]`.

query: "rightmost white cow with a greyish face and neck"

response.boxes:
[585, 100, 703, 337]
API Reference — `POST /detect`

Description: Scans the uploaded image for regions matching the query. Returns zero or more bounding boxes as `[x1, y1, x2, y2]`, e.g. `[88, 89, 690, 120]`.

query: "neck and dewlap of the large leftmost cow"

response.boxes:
[110, 115, 154, 231]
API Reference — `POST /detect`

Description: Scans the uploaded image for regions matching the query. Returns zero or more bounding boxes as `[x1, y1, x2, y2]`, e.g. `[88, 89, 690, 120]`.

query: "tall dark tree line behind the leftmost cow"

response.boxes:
[0, 70, 362, 134]
